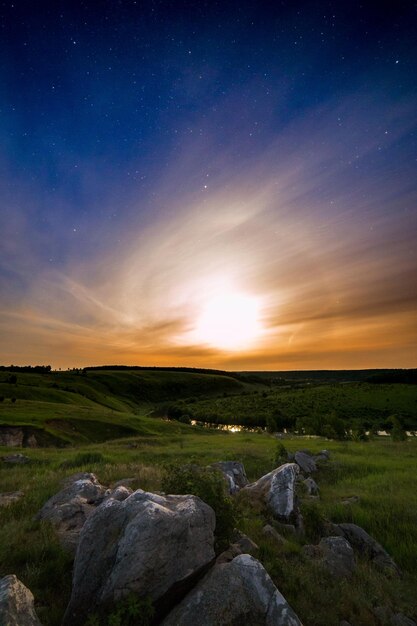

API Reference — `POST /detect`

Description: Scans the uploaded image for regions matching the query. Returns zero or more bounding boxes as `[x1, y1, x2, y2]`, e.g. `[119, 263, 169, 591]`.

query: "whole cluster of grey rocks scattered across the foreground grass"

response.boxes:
[0, 451, 412, 626]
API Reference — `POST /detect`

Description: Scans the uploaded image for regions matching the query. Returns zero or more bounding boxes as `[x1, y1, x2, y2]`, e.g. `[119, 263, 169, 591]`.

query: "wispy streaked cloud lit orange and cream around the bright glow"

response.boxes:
[0, 88, 417, 369]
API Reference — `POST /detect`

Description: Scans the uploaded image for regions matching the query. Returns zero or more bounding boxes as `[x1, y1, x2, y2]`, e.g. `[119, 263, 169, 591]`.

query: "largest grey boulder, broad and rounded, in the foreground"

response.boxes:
[63, 489, 216, 626]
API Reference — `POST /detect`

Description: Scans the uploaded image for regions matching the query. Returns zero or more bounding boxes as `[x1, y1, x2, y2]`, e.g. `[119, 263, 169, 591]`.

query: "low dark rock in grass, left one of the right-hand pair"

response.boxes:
[303, 537, 355, 578]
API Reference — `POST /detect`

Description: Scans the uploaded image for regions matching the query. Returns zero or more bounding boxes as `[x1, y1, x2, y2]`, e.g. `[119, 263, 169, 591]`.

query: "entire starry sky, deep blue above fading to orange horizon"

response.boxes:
[0, 0, 417, 370]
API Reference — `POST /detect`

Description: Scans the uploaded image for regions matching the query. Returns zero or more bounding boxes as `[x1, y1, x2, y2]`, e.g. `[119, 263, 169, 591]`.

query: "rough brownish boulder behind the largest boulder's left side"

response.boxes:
[37, 472, 131, 554]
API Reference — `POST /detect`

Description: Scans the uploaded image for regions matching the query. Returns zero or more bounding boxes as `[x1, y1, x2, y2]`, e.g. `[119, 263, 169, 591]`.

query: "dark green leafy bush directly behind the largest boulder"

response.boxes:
[162, 465, 238, 551]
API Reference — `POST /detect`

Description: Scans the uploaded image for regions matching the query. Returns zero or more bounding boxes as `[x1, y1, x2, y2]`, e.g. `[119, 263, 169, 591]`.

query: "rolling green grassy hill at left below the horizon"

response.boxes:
[0, 370, 248, 445]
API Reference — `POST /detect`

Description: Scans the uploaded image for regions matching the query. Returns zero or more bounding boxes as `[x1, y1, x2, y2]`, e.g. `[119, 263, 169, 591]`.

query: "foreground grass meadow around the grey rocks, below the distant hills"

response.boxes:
[0, 426, 417, 626]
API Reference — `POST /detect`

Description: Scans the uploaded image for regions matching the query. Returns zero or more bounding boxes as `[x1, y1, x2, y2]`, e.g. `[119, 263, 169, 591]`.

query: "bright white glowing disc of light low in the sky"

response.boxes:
[195, 293, 261, 350]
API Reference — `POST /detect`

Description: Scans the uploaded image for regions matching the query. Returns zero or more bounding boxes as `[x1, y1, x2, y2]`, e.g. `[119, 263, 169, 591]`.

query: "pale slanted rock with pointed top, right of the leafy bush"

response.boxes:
[244, 463, 299, 520]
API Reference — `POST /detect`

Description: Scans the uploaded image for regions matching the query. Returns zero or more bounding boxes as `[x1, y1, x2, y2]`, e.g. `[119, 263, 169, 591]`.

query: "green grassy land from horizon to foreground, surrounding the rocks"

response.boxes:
[0, 370, 417, 626]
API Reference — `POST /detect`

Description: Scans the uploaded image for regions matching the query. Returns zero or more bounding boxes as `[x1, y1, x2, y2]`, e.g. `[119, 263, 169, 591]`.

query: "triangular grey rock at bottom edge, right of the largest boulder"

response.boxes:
[162, 554, 301, 626]
